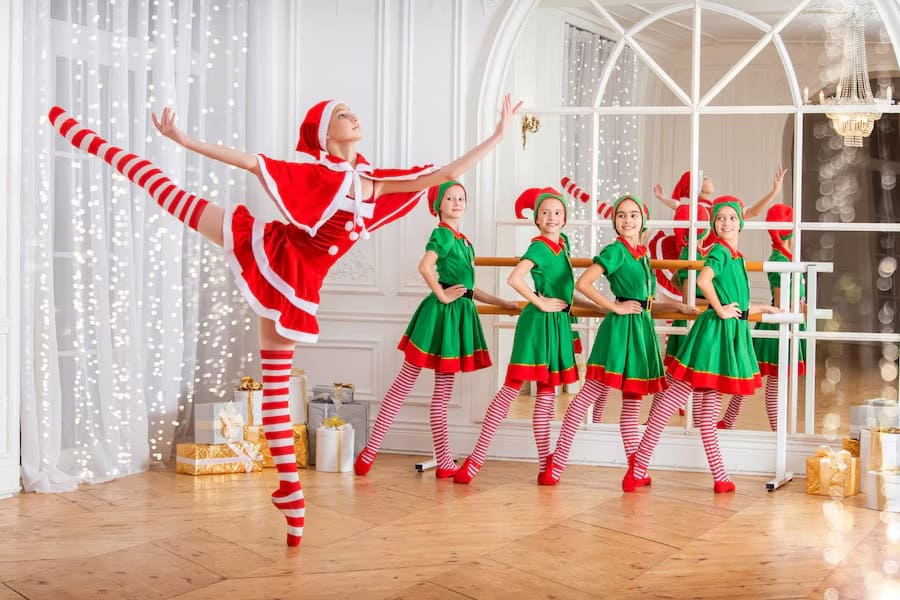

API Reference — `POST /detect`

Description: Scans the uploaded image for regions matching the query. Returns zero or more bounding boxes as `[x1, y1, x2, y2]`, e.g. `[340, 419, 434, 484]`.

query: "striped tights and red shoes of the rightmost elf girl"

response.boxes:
[632, 379, 733, 491]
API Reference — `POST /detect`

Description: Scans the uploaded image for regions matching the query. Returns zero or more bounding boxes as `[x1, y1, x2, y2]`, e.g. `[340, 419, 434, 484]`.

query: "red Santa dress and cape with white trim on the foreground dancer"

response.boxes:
[223, 154, 436, 343]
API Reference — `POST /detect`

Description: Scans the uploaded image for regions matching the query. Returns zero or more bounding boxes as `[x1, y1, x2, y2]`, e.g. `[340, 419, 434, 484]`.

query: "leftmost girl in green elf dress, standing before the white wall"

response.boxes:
[354, 181, 518, 479]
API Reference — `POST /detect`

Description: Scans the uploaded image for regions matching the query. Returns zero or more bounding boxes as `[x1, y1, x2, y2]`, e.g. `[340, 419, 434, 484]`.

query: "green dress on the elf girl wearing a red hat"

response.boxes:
[506, 235, 578, 385]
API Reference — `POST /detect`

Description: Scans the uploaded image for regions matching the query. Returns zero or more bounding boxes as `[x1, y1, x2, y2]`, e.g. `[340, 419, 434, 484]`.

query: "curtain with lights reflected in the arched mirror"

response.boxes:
[560, 24, 646, 256]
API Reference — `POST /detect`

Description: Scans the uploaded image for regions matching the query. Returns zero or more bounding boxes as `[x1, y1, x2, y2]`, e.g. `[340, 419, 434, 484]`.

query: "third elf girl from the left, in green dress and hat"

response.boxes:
[539, 195, 697, 485]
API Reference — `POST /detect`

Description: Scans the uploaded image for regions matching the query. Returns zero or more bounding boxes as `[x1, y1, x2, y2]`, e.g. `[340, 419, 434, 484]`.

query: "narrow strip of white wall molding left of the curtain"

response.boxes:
[0, 0, 23, 497]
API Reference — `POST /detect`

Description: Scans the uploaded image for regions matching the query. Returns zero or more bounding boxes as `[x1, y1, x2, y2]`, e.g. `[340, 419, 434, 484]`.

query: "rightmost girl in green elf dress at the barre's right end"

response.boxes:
[622, 196, 778, 493]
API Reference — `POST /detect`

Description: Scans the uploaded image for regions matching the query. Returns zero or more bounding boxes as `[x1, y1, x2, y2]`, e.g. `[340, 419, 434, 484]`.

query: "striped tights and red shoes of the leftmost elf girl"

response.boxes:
[354, 361, 456, 478]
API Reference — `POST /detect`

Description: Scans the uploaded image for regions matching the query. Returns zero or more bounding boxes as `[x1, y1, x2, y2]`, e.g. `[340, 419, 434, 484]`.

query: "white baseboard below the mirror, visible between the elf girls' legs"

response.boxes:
[381, 420, 821, 478]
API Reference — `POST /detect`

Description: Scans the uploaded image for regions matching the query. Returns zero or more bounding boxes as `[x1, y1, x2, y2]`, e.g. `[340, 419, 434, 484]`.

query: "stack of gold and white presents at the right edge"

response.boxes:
[806, 398, 900, 512]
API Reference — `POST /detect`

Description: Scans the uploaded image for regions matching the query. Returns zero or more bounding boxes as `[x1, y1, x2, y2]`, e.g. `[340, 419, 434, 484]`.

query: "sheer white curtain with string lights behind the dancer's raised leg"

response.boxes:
[21, 0, 274, 492]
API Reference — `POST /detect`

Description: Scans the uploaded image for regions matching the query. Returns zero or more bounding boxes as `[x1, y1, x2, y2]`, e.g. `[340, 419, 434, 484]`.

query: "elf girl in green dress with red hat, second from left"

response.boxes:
[453, 187, 582, 483]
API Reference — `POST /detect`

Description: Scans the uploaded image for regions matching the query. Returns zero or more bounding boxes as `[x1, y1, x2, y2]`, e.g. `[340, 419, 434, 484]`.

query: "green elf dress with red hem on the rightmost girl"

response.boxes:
[668, 237, 762, 395]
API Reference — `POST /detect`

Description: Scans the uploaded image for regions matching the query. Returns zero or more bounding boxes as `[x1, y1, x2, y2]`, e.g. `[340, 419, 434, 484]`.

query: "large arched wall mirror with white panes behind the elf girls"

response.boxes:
[494, 0, 900, 435]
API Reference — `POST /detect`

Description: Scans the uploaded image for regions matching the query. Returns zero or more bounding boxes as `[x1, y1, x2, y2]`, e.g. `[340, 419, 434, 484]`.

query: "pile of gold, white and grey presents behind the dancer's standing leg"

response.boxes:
[175, 369, 369, 475]
